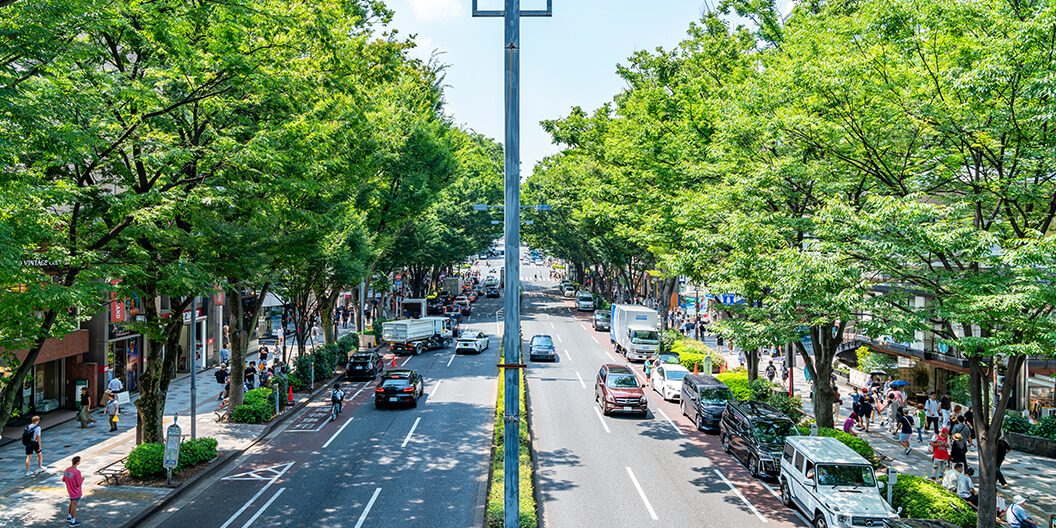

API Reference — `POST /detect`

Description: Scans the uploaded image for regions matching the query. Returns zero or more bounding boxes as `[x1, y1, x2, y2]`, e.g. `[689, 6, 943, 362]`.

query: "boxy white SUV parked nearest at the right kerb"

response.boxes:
[779, 436, 899, 528]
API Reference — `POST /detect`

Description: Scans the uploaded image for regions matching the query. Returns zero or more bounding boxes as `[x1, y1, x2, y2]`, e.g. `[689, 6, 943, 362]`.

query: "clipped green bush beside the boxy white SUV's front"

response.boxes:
[876, 474, 977, 528]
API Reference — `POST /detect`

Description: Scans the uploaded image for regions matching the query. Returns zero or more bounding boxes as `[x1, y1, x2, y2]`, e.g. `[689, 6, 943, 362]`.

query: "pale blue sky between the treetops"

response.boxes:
[386, 0, 726, 177]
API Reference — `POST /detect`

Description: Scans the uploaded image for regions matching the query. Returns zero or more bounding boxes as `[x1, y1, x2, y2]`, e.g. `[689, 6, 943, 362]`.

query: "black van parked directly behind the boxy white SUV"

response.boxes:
[719, 400, 799, 477]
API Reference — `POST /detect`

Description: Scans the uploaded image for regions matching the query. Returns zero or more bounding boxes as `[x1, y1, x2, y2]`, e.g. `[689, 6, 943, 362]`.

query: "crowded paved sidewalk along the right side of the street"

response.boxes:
[760, 358, 1056, 525]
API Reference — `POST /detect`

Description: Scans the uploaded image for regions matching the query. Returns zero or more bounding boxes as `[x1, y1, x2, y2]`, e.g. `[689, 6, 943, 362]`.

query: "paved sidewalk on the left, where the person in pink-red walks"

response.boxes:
[0, 331, 356, 527]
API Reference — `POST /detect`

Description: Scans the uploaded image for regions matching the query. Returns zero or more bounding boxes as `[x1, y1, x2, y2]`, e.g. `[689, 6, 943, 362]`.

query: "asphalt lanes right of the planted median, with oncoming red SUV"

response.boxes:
[522, 274, 807, 528]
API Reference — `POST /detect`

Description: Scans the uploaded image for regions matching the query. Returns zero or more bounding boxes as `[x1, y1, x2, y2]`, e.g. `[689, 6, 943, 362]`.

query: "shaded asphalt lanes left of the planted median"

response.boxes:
[146, 291, 502, 528]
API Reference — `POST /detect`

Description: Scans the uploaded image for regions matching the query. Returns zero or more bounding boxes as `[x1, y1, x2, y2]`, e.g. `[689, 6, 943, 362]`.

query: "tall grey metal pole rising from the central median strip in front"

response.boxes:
[473, 0, 553, 528]
